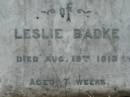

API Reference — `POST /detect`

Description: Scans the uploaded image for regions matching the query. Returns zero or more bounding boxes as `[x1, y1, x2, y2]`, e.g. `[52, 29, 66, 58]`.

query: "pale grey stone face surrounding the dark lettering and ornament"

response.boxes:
[0, 0, 130, 91]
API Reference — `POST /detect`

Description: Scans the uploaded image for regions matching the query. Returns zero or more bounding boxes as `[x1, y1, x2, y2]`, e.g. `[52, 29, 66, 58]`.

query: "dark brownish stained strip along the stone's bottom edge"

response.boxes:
[0, 86, 130, 97]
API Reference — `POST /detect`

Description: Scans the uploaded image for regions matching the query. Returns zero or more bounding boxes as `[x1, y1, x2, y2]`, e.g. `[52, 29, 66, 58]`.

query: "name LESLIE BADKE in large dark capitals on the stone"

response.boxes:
[14, 27, 119, 40]
